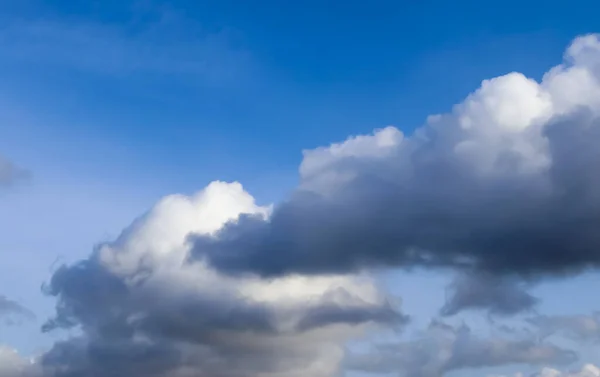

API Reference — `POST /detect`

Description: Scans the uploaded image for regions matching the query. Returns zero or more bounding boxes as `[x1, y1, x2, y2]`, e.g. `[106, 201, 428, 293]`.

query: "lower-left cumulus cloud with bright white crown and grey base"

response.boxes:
[40, 182, 408, 377]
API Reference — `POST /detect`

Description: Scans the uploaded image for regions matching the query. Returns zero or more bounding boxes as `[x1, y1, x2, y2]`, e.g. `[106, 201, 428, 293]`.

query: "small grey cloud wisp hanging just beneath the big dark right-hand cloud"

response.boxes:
[440, 274, 539, 316]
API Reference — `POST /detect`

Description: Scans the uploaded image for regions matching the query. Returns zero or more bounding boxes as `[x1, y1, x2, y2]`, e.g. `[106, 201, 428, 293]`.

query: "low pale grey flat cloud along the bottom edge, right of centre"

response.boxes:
[348, 321, 577, 377]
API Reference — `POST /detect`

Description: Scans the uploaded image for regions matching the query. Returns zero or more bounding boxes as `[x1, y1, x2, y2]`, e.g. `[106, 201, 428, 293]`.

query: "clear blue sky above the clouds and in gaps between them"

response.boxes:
[0, 0, 600, 375]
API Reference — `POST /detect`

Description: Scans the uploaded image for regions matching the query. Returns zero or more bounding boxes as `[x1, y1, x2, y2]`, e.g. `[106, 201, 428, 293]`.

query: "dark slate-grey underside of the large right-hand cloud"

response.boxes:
[193, 111, 600, 276]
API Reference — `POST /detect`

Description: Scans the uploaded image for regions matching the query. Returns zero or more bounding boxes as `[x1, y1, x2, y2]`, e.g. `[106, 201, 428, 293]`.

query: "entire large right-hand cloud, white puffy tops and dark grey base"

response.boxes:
[193, 35, 600, 284]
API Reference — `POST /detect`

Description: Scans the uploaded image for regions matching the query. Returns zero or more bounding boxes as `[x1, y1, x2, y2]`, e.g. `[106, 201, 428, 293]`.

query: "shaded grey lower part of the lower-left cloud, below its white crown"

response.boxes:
[40, 216, 408, 377]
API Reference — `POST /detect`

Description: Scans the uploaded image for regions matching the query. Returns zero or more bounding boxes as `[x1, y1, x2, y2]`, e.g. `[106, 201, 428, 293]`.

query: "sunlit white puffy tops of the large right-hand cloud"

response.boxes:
[300, 35, 600, 184]
